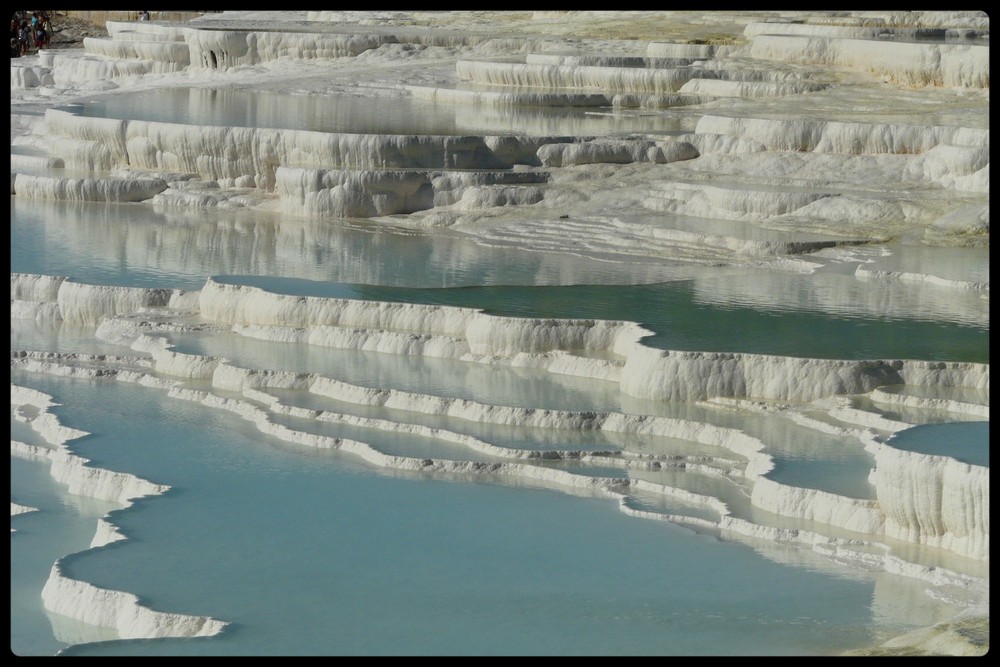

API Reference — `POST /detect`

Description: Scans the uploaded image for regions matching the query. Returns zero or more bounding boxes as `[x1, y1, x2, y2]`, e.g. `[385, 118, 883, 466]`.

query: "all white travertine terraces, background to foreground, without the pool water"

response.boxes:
[10, 11, 989, 654]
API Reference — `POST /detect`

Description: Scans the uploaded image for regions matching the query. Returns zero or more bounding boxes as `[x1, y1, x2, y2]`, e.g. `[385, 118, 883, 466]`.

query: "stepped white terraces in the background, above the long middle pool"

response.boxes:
[11, 13, 989, 262]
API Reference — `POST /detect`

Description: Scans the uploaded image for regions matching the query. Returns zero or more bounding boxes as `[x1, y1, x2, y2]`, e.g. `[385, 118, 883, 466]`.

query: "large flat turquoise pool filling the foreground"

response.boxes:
[12, 373, 960, 655]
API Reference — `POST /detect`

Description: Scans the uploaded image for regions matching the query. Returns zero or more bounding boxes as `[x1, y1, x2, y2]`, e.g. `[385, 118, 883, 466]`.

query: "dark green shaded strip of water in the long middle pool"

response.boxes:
[220, 274, 989, 363]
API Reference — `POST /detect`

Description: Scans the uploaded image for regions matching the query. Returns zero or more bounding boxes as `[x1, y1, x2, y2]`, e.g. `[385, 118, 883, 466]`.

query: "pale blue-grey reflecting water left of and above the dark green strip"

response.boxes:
[10, 197, 682, 289]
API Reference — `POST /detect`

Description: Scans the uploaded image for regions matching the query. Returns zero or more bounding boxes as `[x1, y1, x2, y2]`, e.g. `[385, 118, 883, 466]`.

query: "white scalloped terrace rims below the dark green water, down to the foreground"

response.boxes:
[11, 266, 989, 648]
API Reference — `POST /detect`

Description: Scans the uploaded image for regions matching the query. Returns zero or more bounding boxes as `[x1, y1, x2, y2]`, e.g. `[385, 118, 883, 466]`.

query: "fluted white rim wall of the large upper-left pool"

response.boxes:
[45, 109, 565, 191]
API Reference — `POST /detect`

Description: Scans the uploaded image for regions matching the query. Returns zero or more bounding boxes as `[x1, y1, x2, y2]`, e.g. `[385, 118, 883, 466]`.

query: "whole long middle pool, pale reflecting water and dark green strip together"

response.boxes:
[11, 197, 989, 361]
